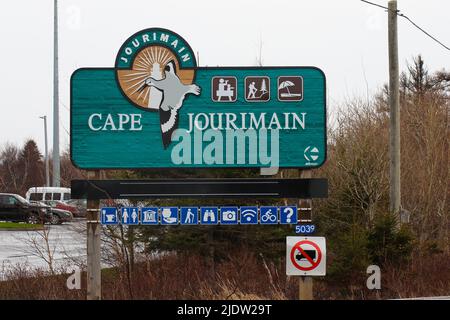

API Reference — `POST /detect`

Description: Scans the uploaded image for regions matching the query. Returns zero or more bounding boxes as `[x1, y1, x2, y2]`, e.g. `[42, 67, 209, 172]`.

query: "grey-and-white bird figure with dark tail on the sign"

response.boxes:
[140, 60, 201, 149]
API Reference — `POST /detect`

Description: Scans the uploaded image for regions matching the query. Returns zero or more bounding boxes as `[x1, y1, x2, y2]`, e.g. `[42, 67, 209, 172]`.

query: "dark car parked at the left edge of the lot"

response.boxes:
[0, 193, 52, 224]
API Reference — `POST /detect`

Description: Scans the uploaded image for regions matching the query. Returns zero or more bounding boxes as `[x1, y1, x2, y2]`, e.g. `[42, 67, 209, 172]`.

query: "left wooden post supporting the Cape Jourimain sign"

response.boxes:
[86, 171, 102, 300]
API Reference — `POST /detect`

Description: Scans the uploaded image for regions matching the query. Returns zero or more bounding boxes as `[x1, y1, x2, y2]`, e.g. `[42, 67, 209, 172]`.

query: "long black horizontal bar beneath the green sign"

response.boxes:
[71, 179, 328, 200]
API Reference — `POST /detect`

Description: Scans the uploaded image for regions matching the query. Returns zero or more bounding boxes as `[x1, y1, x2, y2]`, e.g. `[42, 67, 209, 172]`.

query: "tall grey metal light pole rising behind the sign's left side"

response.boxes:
[52, 0, 61, 187]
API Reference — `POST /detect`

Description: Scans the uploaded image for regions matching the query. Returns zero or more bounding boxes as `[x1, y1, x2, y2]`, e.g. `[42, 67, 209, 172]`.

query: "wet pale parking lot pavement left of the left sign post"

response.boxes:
[0, 220, 86, 278]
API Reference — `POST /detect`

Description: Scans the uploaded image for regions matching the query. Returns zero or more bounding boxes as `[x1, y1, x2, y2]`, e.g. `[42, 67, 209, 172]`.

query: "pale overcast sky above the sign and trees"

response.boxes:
[0, 0, 450, 151]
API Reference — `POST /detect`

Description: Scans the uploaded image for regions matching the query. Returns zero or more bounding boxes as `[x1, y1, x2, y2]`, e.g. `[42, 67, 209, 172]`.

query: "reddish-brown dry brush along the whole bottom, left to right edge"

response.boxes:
[0, 252, 450, 300]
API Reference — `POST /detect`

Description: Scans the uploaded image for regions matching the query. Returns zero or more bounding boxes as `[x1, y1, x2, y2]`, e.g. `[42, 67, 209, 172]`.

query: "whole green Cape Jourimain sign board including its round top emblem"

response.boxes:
[71, 28, 326, 169]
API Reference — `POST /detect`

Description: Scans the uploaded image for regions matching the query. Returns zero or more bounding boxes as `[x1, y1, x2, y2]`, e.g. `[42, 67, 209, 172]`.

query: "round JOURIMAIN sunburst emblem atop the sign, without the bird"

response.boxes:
[116, 28, 197, 111]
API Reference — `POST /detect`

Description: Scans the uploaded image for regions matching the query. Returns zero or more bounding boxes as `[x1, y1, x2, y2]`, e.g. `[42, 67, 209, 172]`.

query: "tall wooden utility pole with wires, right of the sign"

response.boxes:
[388, 0, 401, 223]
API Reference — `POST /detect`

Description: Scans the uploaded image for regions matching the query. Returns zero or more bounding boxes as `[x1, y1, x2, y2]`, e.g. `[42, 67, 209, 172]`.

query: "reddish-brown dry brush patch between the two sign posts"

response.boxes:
[104, 253, 292, 299]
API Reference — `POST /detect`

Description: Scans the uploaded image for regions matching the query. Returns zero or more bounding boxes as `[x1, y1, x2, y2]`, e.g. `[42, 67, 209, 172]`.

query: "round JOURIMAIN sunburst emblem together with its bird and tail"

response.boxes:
[116, 28, 201, 149]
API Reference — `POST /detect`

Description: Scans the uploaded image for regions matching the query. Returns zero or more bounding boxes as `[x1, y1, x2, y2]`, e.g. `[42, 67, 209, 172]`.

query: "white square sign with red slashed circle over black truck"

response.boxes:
[286, 237, 326, 276]
